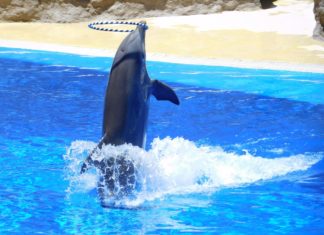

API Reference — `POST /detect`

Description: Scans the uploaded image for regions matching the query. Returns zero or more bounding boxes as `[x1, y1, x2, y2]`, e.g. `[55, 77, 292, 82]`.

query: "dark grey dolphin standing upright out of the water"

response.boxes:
[81, 22, 179, 198]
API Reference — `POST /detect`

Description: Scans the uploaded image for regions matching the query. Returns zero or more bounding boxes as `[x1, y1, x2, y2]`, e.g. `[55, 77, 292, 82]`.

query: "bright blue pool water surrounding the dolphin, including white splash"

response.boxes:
[0, 48, 324, 234]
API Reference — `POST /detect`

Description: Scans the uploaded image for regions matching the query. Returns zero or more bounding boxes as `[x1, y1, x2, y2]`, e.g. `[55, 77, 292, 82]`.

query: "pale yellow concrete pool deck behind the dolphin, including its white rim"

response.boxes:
[0, 0, 324, 73]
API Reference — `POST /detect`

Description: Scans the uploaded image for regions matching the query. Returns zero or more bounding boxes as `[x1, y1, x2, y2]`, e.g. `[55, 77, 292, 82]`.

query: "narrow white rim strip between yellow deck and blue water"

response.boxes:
[0, 40, 324, 73]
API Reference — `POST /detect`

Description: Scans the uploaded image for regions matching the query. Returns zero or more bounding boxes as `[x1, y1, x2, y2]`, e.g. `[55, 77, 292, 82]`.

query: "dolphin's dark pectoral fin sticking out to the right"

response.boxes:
[151, 80, 180, 105]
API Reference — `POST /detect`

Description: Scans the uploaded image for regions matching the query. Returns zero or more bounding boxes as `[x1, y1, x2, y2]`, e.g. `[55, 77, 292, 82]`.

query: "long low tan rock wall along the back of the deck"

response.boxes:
[0, 0, 260, 22]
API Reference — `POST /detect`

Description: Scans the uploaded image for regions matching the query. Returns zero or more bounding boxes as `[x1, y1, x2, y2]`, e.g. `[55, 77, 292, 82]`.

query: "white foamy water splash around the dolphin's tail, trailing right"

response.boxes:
[64, 138, 322, 206]
